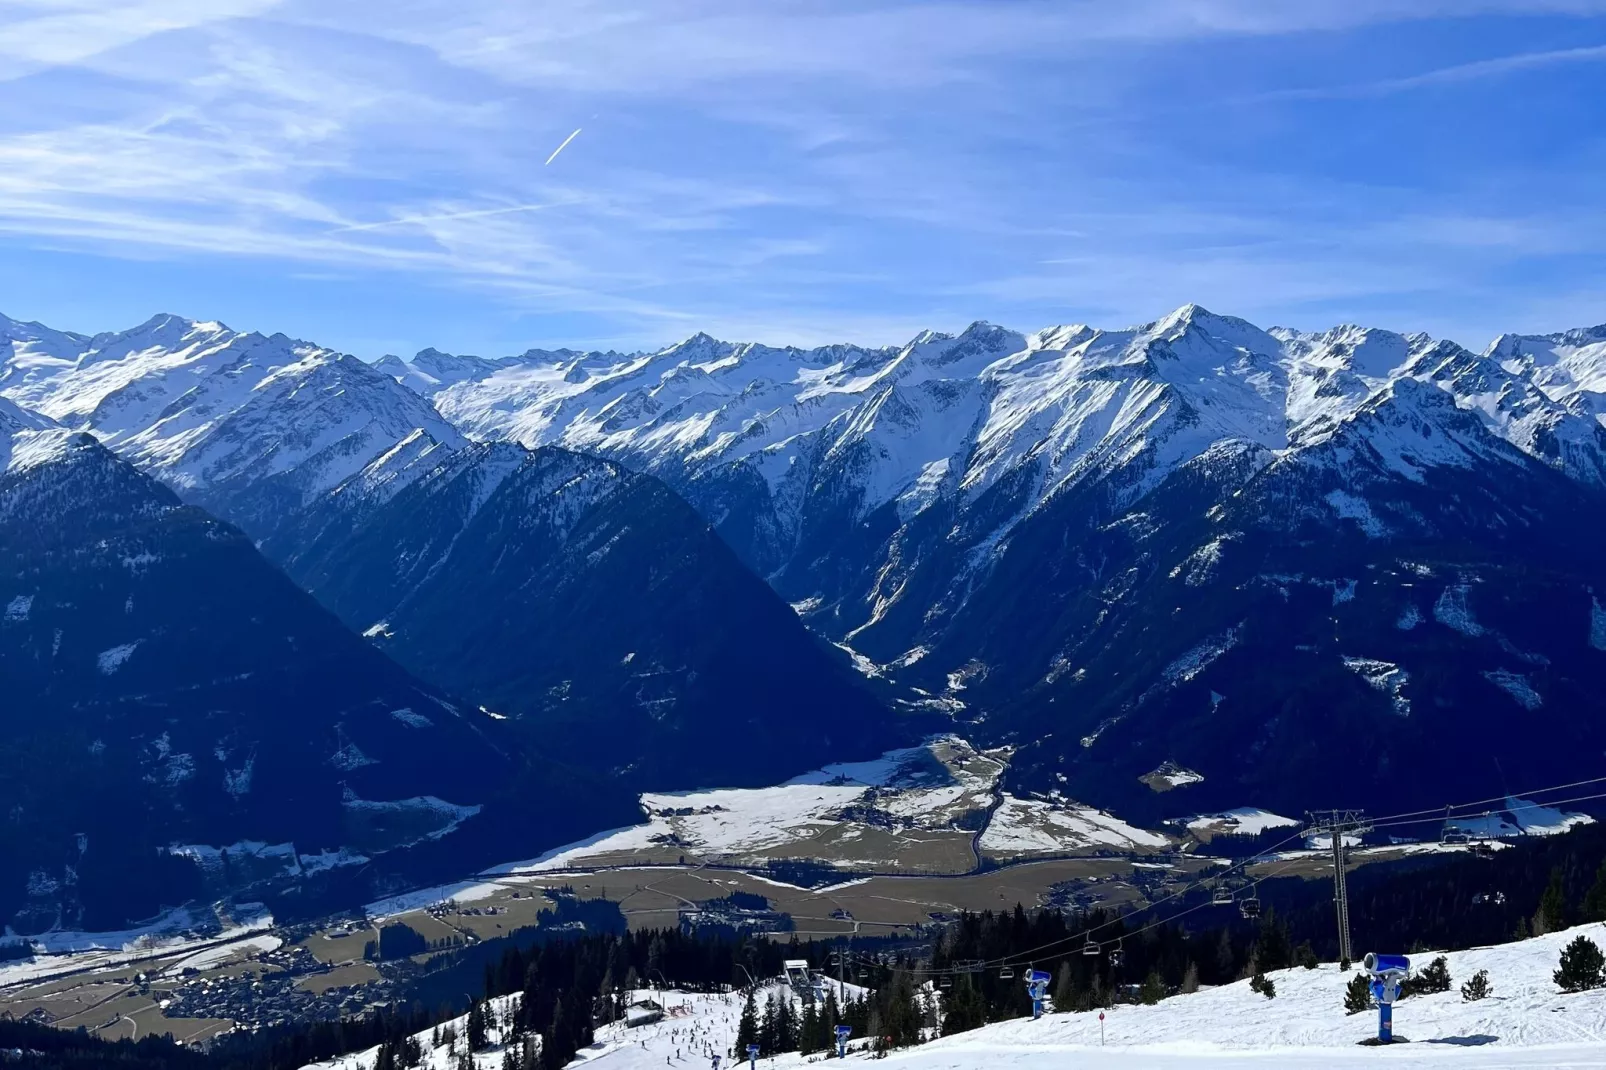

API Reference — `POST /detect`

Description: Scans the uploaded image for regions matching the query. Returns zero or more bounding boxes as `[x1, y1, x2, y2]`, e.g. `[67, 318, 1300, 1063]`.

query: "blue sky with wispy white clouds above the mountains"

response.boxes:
[0, 0, 1606, 357]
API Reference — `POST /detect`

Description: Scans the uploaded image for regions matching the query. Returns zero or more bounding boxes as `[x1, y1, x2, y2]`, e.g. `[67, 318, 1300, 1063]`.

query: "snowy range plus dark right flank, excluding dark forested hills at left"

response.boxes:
[0, 305, 1606, 841]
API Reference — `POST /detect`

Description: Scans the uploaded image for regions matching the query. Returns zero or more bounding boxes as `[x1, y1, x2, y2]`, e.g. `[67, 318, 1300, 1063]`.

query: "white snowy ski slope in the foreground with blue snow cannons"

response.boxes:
[306, 924, 1606, 1070]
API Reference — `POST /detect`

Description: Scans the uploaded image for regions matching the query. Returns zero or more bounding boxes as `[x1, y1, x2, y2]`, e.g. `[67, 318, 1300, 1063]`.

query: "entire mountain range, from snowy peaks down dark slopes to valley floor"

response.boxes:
[0, 305, 1606, 932]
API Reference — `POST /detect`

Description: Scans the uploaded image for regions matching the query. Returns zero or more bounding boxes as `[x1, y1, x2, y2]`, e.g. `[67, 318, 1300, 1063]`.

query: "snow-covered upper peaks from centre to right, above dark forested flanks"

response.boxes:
[381, 305, 1606, 642]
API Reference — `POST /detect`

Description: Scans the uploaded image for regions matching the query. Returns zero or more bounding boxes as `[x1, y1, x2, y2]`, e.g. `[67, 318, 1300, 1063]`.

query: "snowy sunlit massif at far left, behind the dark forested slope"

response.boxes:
[0, 315, 463, 529]
